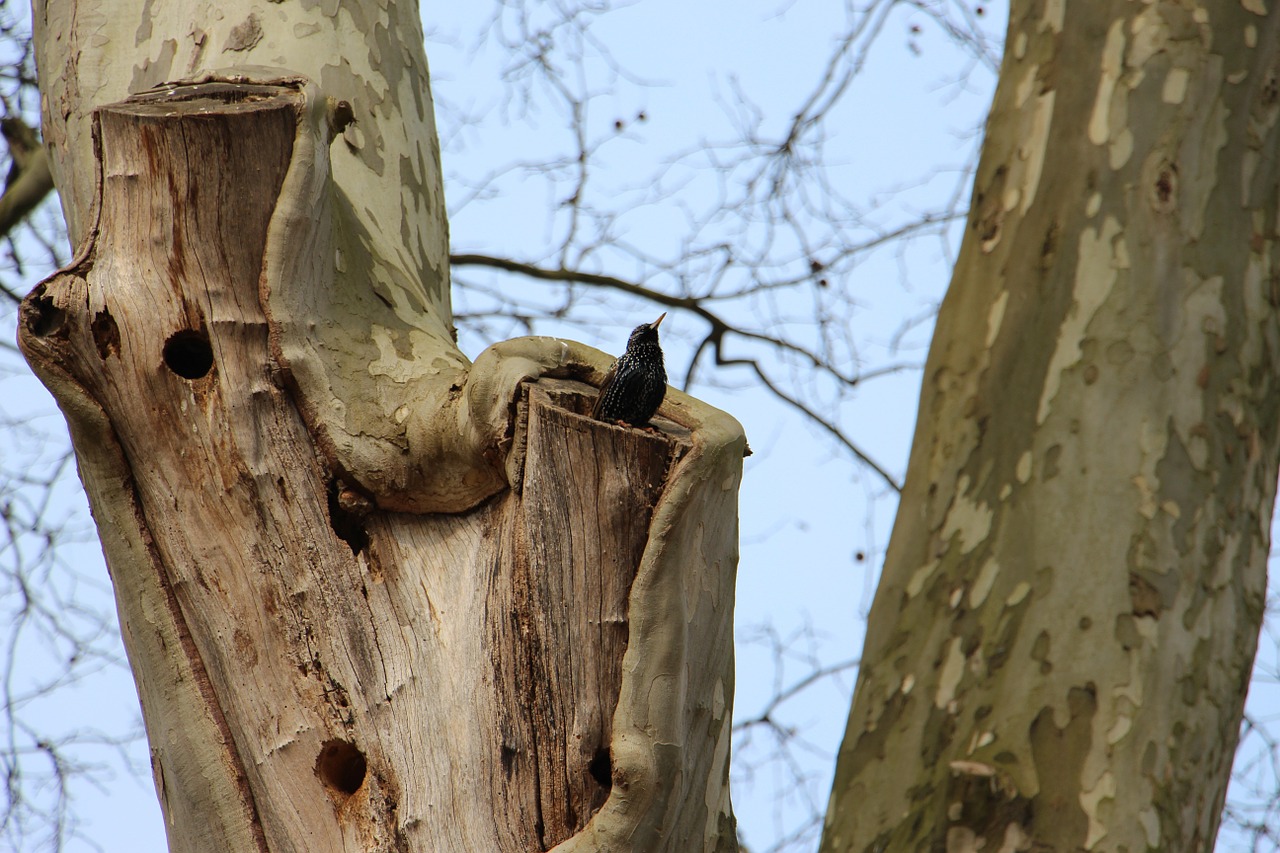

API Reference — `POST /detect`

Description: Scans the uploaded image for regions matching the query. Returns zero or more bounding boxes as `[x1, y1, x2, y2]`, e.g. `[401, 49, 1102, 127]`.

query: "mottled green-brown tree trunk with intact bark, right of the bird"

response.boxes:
[822, 3, 1280, 850]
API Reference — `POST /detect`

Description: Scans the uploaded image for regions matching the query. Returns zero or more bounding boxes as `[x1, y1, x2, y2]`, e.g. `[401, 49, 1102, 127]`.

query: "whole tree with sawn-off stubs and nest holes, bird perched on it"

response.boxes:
[19, 3, 744, 852]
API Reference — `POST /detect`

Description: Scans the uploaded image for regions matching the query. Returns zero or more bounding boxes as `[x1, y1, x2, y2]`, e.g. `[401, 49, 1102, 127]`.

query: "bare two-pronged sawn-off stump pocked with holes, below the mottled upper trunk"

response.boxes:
[20, 83, 740, 853]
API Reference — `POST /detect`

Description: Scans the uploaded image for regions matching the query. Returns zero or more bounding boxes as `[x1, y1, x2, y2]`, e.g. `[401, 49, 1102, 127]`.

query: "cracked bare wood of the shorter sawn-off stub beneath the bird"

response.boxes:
[489, 380, 675, 849]
